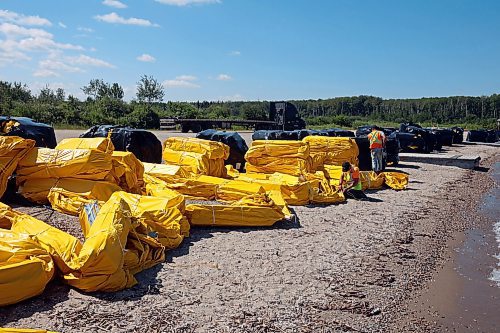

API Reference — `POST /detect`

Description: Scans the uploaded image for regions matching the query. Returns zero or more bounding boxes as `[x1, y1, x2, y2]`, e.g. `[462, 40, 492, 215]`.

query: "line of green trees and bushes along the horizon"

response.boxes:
[0, 75, 500, 129]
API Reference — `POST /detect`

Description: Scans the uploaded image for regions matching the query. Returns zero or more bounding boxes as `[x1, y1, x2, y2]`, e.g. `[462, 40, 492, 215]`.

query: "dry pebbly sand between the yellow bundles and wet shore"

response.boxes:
[0, 133, 499, 332]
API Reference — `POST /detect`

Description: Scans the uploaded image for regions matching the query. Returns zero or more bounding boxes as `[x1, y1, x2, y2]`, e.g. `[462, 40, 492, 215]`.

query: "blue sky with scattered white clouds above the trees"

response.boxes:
[0, 0, 500, 101]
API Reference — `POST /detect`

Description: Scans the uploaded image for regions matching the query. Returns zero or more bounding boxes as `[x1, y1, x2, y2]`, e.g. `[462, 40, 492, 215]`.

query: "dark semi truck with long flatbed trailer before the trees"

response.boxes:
[160, 102, 306, 133]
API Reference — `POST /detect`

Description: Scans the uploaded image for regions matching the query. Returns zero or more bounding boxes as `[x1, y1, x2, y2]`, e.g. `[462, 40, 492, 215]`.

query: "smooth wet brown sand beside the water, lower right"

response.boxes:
[390, 155, 500, 333]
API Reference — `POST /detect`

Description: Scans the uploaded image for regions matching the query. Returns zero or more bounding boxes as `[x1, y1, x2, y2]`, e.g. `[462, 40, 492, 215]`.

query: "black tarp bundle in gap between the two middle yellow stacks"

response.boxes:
[196, 129, 249, 171]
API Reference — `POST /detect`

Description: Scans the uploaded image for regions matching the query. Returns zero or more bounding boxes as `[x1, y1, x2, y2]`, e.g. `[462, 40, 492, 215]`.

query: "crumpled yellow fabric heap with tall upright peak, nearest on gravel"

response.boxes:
[11, 196, 165, 292]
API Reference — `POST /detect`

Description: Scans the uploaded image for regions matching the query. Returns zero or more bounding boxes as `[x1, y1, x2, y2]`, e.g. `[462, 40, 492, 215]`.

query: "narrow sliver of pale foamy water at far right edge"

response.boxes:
[483, 163, 500, 288]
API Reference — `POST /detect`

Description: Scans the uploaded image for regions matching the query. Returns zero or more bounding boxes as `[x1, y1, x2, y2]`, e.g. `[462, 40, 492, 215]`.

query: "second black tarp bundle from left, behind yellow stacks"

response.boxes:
[80, 125, 162, 163]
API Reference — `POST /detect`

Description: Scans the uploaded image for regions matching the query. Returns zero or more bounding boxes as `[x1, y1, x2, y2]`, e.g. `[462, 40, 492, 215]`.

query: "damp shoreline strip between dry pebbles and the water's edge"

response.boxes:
[390, 154, 500, 333]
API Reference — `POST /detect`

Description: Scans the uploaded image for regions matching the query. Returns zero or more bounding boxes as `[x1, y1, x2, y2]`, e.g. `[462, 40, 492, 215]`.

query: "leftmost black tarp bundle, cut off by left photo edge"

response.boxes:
[0, 116, 57, 148]
